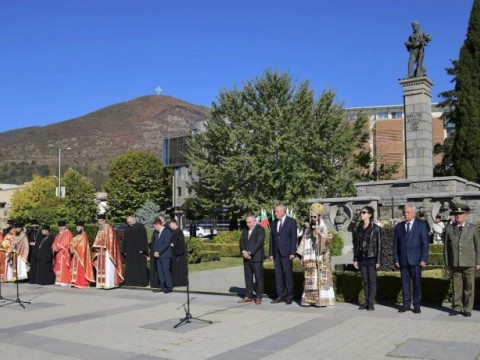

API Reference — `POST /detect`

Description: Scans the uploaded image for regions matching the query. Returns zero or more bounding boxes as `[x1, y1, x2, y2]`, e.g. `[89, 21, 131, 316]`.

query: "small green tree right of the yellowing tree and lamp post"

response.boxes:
[61, 168, 97, 223]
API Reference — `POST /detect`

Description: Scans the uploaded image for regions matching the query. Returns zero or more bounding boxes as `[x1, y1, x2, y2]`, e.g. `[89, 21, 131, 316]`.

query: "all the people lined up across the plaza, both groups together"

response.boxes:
[0, 203, 480, 317]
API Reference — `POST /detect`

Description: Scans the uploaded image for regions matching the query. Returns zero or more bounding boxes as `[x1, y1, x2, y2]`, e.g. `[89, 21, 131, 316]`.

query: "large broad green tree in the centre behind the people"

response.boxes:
[188, 71, 368, 217]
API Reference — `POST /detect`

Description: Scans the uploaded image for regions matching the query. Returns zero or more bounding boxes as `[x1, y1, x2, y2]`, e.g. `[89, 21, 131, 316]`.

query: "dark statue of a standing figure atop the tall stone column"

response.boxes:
[405, 21, 432, 78]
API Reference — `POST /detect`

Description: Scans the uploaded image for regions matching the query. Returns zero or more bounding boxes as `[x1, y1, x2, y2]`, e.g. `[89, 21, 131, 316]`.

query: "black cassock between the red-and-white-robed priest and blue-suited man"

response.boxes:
[122, 223, 148, 286]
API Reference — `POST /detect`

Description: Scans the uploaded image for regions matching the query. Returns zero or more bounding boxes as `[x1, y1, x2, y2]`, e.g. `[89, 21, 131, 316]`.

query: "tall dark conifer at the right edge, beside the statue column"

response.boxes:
[452, 0, 480, 183]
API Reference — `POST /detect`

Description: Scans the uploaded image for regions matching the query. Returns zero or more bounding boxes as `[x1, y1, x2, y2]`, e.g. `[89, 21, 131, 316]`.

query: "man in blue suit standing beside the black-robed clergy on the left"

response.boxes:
[153, 216, 173, 294]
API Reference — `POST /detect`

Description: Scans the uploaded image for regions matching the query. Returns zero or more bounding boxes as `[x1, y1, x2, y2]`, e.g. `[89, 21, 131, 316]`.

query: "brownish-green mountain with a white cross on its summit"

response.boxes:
[0, 95, 207, 188]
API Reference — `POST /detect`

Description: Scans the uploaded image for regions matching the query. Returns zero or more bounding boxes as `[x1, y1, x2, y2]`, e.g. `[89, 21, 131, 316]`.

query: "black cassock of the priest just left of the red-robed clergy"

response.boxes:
[28, 235, 55, 285]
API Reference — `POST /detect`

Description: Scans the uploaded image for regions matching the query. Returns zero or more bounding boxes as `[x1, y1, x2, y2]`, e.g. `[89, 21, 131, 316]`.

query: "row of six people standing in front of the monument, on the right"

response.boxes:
[238, 203, 480, 317]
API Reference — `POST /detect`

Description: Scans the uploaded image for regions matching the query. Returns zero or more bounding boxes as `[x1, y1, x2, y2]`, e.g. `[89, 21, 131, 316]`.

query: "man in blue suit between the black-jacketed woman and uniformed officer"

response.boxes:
[393, 204, 429, 314]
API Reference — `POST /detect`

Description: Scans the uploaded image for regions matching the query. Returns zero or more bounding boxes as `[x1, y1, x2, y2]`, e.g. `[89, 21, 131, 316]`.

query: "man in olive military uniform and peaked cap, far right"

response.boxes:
[445, 204, 480, 317]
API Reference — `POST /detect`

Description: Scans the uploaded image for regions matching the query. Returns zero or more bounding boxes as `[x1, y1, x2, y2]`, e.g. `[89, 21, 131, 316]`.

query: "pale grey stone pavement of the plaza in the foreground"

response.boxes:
[0, 267, 480, 360]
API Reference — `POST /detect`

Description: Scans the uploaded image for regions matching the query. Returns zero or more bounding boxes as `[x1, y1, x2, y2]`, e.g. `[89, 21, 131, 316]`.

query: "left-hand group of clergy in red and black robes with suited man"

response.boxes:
[0, 214, 188, 293]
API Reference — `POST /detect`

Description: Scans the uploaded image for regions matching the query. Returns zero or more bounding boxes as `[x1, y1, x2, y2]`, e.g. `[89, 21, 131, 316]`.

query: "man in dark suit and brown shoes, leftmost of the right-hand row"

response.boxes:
[238, 215, 265, 305]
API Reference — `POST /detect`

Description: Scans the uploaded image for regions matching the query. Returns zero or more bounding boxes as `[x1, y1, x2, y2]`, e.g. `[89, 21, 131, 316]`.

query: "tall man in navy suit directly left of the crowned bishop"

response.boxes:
[269, 205, 297, 305]
